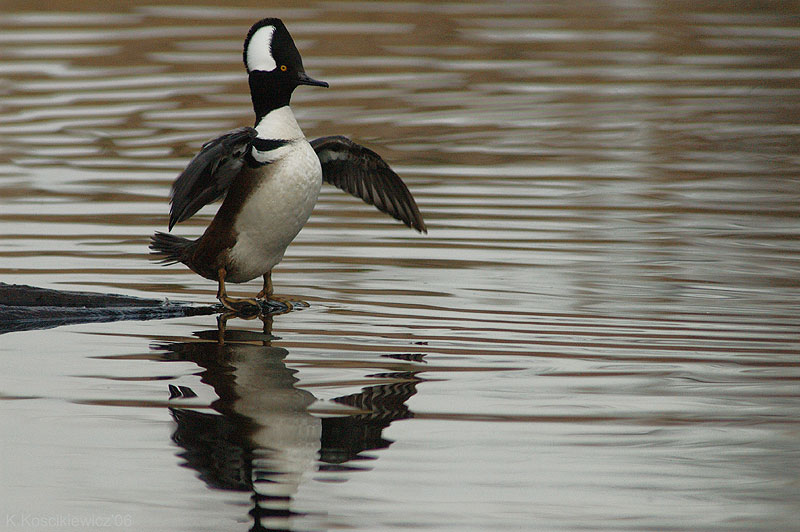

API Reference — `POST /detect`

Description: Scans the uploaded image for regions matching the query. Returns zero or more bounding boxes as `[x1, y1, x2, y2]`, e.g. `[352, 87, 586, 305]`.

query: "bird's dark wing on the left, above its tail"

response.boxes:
[169, 127, 257, 230]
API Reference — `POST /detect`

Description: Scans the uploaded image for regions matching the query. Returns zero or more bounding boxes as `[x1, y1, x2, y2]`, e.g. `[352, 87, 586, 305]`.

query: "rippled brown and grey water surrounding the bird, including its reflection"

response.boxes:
[0, 0, 800, 531]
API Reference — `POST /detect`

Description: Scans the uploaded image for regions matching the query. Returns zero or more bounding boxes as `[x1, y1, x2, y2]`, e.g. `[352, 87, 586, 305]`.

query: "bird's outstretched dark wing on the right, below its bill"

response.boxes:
[311, 136, 428, 233]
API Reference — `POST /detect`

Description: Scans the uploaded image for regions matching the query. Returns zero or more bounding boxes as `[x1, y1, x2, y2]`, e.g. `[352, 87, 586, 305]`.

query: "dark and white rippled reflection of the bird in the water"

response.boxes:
[155, 317, 420, 530]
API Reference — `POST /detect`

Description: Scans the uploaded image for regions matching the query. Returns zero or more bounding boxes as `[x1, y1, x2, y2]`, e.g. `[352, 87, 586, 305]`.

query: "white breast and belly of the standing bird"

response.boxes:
[228, 107, 322, 283]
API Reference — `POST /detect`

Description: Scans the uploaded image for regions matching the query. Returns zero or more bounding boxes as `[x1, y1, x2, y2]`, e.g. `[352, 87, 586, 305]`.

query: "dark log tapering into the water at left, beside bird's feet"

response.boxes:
[0, 283, 218, 334]
